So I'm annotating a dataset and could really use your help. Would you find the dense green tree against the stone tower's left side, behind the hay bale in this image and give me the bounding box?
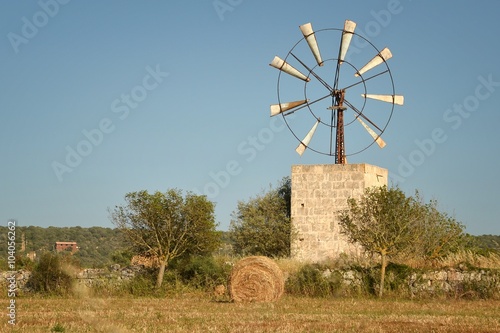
[229,178,291,257]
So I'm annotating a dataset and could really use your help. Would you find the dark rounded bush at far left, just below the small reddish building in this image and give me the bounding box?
[27,252,73,295]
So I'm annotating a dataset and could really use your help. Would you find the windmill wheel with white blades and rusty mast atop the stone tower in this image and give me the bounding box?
[270,20,404,164]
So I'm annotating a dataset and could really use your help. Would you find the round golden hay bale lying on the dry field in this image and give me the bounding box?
[229,256,285,302]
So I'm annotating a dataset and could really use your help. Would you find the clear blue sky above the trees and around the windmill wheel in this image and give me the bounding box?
[0,0,500,234]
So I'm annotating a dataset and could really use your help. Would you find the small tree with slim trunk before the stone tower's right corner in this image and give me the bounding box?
[339,186,422,297]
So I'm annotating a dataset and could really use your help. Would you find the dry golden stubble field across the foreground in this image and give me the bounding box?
[0,294,500,333]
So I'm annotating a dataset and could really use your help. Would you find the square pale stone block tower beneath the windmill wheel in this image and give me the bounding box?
[291,164,388,262]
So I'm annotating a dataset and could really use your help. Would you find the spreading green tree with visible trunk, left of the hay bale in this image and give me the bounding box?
[110,189,220,288]
